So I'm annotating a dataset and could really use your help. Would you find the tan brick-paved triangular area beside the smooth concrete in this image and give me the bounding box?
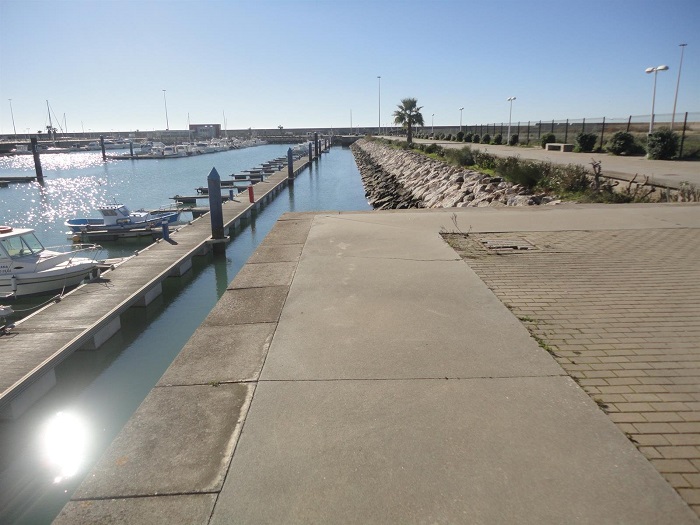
[445,229,700,515]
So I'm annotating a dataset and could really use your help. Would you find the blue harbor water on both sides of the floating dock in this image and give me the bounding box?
[0,145,370,524]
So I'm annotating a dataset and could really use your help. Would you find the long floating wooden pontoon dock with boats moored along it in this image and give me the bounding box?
[0,149,322,419]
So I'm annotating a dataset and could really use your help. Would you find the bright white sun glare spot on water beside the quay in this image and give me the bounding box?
[41,412,89,484]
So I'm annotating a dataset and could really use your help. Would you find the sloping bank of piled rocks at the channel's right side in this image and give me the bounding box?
[352,139,559,209]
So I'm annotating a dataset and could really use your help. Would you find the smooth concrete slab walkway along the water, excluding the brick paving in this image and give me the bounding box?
[56,205,700,524]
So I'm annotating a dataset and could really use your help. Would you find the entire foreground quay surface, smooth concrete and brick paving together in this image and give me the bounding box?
[55,205,700,525]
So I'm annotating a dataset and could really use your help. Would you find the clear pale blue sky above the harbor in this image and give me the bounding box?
[0,0,700,133]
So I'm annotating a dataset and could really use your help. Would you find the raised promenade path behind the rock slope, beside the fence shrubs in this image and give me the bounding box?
[404,137,700,189]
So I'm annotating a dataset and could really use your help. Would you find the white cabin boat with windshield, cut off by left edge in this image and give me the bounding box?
[0,226,100,298]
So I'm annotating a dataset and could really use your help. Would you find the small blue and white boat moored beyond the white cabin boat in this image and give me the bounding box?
[63,204,180,233]
